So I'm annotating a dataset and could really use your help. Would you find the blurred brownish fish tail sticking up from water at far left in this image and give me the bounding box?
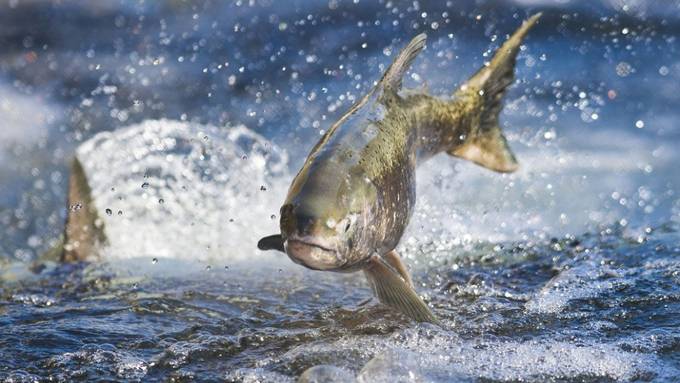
[61,157,107,262]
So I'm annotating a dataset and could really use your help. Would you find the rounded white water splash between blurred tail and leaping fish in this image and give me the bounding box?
[77,120,289,260]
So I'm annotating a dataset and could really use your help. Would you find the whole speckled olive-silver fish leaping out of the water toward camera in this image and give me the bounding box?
[258,13,541,323]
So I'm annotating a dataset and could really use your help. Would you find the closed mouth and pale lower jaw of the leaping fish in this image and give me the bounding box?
[285,237,342,270]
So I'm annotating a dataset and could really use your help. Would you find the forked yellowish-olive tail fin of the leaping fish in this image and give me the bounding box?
[449,13,541,173]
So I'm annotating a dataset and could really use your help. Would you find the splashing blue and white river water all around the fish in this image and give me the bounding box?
[0,0,680,382]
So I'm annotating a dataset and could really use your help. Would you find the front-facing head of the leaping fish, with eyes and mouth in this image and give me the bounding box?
[280,170,376,271]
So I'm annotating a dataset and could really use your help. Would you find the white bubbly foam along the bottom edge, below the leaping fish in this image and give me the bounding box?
[270,326,677,382]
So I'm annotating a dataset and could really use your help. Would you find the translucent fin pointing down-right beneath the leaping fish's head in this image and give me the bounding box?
[364,255,439,323]
